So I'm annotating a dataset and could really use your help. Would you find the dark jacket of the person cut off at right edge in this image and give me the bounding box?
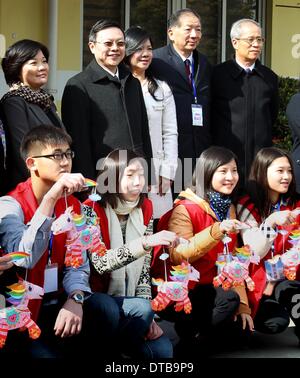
[286,92,300,193]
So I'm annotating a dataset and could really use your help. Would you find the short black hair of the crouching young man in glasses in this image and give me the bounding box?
[20,125,72,161]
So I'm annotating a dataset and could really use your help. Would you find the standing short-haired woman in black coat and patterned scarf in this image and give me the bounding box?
[1,39,63,189]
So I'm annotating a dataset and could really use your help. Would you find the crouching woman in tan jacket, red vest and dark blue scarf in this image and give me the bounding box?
[151,147,252,354]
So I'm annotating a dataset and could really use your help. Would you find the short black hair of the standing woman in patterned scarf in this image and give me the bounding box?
[2,39,49,86]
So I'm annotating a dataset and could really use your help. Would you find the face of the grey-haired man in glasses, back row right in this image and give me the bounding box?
[231,22,262,65]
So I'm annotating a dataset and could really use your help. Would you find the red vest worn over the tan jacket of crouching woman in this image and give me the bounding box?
[151,199,236,289]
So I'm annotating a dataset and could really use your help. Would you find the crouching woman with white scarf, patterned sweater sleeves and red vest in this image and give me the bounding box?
[85,150,176,359]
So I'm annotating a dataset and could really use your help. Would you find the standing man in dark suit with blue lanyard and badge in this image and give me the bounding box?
[151,8,211,192]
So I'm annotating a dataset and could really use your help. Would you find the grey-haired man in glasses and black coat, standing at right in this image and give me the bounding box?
[211,19,278,186]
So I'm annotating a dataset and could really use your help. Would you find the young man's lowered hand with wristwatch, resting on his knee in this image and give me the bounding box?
[54,298,83,337]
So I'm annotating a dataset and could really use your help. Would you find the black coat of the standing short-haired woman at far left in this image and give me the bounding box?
[1,96,63,191]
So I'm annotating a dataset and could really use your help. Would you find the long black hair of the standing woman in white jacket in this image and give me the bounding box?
[124,26,162,101]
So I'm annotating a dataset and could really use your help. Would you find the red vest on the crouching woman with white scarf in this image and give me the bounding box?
[84,198,153,293]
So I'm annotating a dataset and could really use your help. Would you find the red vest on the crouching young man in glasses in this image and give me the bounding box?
[8,178,81,321]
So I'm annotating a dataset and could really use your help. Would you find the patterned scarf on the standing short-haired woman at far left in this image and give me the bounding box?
[1,83,53,111]
